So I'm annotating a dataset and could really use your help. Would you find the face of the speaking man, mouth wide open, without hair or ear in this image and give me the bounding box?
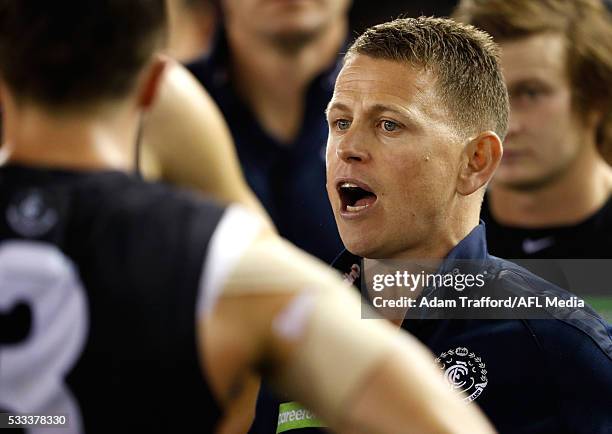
[327,55,461,258]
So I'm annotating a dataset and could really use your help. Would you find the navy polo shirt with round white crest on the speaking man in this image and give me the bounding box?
[257,224,612,434]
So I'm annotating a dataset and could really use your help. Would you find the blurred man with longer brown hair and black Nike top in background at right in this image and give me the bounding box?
[454,0,612,258]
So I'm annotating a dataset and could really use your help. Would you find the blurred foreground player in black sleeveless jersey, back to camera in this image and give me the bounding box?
[0,0,491,433]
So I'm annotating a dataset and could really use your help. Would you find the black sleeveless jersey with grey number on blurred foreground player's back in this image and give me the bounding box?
[0,165,225,434]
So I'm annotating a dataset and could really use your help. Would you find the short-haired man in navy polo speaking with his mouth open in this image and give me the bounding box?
[256,17,612,434]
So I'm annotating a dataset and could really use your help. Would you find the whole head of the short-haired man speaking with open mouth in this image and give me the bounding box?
[327,18,508,259]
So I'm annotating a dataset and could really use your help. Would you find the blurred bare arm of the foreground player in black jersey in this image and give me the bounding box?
[199,209,493,433]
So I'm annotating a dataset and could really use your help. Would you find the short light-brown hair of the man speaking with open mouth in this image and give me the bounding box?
[346,17,509,139]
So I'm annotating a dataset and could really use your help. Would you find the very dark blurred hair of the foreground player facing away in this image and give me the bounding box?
[0,0,166,108]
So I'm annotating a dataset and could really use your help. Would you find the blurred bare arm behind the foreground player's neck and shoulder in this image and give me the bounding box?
[141,60,272,231]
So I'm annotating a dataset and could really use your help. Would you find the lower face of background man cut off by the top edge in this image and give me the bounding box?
[223,0,350,39]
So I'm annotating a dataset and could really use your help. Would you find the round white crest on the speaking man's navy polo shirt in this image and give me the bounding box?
[436,347,489,402]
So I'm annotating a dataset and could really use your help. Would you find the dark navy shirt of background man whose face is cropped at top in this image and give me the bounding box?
[187,31,342,262]
